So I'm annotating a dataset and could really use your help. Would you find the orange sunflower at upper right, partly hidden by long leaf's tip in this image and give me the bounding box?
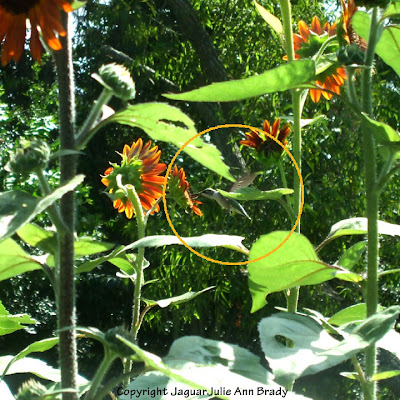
[293,17,346,103]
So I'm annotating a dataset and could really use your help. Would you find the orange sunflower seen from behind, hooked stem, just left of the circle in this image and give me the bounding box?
[101,138,167,219]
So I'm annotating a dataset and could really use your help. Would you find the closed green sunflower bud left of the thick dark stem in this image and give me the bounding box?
[6,139,50,175]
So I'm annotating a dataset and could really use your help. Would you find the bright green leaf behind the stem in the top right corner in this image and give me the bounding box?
[351,9,400,76]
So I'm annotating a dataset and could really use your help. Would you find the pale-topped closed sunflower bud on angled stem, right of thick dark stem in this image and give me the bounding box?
[94,63,136,100]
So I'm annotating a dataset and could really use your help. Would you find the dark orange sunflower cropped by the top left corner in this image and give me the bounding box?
[0,0,72,65]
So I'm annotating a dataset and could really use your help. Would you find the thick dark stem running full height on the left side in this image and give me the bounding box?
[55,12,78,400]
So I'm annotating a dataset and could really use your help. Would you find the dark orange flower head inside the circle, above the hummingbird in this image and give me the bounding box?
[239,118,290,165]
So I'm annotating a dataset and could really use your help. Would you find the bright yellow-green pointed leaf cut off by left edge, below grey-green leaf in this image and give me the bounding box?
[0,239,41,281]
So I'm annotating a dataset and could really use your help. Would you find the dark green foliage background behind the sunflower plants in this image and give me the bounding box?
[0,0,400,399]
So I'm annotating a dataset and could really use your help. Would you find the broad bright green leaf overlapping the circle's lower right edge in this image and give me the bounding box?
[248,231,347,312]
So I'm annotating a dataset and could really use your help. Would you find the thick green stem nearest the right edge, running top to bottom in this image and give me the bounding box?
[361,7,380,400]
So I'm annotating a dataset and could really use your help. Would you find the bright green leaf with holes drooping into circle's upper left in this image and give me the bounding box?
[96,103,235,182]
